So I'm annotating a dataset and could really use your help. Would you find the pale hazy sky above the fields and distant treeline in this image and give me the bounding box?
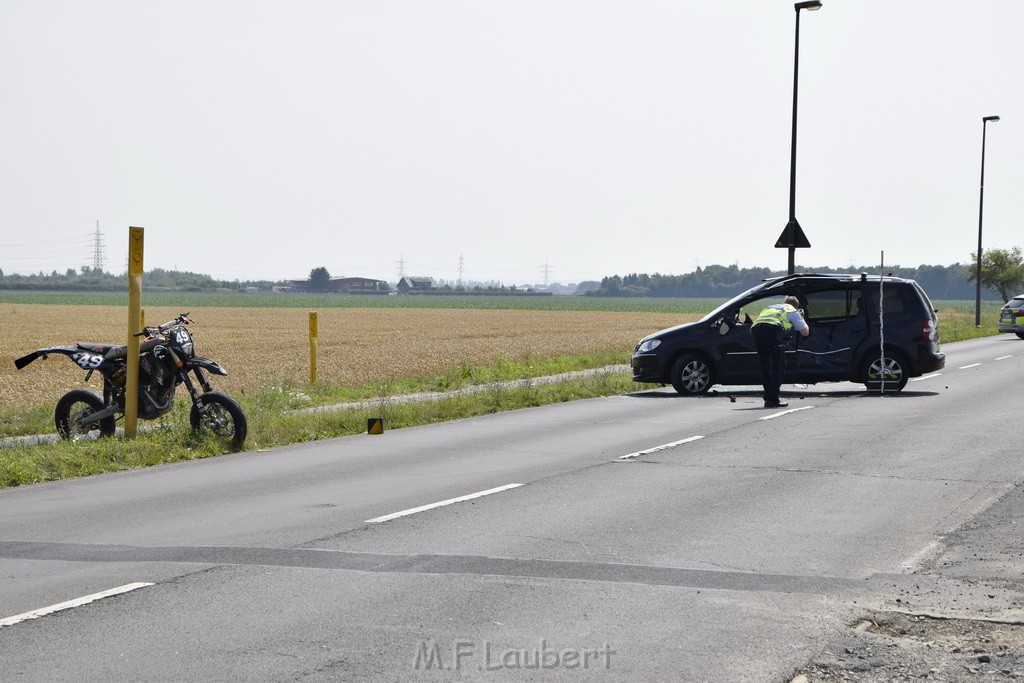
[0,0,1024,285]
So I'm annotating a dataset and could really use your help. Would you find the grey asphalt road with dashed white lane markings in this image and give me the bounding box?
[0,336,1024,681]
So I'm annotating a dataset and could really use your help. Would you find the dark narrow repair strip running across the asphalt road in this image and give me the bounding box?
[0,541,861,595]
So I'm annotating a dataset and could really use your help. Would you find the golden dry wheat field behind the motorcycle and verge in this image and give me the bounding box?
[0,303,698,410]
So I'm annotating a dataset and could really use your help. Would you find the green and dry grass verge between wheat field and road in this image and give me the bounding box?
[0,356,636,486]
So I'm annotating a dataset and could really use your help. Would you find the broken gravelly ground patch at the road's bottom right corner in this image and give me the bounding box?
[792,611,1024,683]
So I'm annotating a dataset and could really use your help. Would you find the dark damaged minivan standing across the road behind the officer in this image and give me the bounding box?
[631,273,946,395]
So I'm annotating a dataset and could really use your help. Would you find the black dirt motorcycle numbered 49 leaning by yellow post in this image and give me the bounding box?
[14,312,248,449]
